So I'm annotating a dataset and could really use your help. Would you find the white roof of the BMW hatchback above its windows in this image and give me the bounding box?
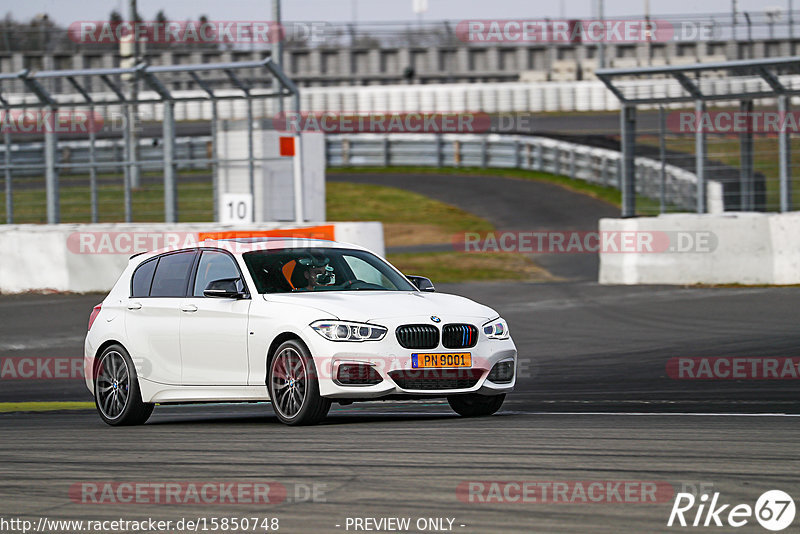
[131,237,368,262]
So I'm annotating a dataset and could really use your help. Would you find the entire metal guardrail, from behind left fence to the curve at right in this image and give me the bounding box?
[0,133,723,220]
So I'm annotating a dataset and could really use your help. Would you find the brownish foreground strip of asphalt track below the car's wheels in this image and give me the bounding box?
[0,406,800,533]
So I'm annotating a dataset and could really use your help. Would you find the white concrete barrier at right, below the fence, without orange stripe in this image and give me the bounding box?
[599,212,800,285]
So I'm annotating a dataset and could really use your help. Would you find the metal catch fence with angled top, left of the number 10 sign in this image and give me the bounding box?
[0,58,302,223]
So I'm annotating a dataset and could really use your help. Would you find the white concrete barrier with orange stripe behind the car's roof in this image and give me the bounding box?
[0,222,385,293]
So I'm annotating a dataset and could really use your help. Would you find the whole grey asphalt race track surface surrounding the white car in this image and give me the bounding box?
[0,179,800,533]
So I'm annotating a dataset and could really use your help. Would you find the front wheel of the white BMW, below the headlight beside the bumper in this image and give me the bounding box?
[267,339,331,426]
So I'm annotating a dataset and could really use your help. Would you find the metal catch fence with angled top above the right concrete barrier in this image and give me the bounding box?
[598,58,800,216]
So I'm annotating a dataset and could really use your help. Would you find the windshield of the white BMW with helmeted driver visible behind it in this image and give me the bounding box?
[244,248,417,294]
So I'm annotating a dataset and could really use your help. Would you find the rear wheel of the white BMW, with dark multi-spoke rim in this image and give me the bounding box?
[94,345,155,426]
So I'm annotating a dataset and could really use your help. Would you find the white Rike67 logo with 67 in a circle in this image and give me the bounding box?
[667,490,795,532]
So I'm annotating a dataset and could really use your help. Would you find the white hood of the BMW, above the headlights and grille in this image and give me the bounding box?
[264,291,498,323]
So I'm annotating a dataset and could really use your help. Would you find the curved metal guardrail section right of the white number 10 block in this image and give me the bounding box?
[326,134,723,212]
